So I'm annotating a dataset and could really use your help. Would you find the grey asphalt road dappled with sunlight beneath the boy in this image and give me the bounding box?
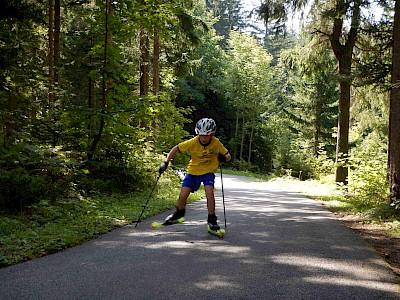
[0,175,400,300]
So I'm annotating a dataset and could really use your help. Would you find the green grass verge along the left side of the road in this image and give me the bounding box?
[0,172,203,267]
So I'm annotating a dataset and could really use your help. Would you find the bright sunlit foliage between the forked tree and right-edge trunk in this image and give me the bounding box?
[342,86,389,210]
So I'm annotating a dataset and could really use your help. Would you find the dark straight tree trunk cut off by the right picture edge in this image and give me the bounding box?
[388,0,400,204]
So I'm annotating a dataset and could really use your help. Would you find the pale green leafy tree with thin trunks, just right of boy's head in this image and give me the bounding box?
[226,31,272,164]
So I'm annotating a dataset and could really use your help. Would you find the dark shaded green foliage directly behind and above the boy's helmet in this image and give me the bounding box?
[175,25,236,144]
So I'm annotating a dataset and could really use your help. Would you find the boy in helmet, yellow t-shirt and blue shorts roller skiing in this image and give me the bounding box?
[158,118,231,231]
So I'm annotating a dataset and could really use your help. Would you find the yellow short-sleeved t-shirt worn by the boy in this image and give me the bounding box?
[178,136,228,175]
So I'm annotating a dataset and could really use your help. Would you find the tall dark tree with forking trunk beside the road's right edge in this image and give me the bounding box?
[258,0,380,183]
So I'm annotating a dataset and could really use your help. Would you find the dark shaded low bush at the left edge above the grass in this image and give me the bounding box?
[0,143,73,210]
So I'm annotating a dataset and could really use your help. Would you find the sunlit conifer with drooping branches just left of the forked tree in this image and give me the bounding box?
[280,39,337,157]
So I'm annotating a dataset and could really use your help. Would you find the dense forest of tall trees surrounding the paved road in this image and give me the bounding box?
[0,0,400,262]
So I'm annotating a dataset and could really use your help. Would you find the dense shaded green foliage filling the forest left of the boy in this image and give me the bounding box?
[0,0,200,213]
